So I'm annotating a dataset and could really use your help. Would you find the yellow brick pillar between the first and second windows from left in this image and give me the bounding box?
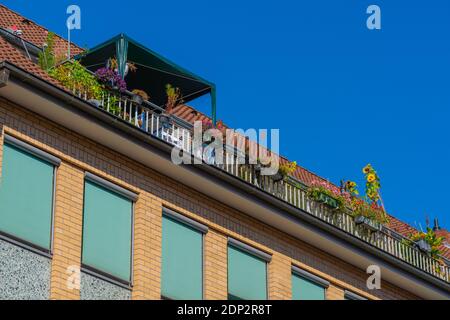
[50,163,84,300]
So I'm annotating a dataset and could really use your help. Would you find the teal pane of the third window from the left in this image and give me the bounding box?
[161,216,203,300]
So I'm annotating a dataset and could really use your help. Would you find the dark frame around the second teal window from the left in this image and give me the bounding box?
[80,172,139,290]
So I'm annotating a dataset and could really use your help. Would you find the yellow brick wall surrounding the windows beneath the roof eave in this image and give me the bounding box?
[0,98,417,299]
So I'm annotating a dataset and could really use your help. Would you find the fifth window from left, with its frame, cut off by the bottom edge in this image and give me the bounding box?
[292,267,330,300]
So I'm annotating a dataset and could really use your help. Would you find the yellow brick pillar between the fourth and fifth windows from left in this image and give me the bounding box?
[268,253,292,300]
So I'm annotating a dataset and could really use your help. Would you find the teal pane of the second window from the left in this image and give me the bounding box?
[82,181,133,282]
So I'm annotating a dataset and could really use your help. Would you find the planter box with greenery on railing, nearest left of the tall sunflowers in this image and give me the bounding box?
[307,180,350,211]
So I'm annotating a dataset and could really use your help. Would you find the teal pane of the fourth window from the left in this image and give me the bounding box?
[228,246,267,300]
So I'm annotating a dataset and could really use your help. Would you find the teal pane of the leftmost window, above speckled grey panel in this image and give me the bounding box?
[0,144,55,250]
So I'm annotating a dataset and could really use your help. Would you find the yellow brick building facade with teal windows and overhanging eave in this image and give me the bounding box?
[0,7,450,300]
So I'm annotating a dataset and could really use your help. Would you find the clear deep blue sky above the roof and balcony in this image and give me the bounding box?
[1,0,450,228]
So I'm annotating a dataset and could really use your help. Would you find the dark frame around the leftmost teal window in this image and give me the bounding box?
[0,133,62,258]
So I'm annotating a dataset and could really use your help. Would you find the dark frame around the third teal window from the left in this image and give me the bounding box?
[160,207,209,301]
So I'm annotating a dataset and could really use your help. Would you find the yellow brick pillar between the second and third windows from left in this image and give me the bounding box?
[132,194,162,300]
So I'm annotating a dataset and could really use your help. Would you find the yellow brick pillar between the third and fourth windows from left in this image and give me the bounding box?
[204,230,228,300]
